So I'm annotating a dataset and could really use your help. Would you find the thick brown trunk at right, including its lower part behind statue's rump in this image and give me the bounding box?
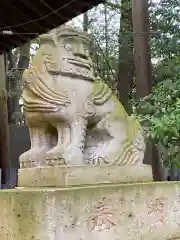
[132,0,163,181]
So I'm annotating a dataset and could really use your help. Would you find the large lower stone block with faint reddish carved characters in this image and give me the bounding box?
[0,182,180,240]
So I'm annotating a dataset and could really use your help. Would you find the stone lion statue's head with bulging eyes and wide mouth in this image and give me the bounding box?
[40,27,94,79]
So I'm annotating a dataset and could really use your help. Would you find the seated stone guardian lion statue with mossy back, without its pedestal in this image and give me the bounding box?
[20,27,145,168]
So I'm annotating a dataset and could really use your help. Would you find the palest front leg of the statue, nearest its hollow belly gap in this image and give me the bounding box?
[64,117,87,165]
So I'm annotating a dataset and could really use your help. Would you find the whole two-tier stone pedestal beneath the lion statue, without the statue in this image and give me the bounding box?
[0,166,180,240]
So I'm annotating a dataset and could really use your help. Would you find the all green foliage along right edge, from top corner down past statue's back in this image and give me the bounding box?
[133,0,180,167]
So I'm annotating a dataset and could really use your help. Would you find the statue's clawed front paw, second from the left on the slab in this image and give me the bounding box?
[45,147,66,166]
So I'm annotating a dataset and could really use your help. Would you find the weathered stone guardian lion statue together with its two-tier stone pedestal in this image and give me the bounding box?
[13,25,162,240]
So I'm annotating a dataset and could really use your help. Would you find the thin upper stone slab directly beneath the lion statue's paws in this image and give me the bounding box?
[18,165,152,187]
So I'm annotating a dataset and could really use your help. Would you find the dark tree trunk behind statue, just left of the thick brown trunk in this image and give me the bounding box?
[117,0,134,114]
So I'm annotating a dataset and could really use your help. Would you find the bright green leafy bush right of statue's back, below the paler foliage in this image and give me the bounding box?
[135,57,180,165]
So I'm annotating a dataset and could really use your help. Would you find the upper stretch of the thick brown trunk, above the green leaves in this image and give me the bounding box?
[133,0,152,98]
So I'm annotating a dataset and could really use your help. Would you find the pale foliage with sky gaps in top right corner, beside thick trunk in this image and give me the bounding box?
[150,0,180,58]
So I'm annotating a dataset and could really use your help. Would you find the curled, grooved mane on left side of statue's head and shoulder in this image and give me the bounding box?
[23,28,93,112]
